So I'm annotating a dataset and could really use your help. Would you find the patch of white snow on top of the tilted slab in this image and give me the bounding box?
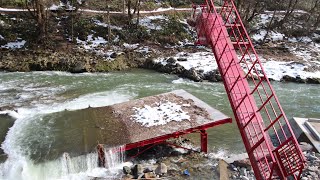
[131,101,190,127]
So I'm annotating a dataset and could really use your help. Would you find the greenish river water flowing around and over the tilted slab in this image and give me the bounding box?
[0,70,320,180]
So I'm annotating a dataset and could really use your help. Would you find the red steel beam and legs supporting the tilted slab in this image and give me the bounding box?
[97,118,232,167]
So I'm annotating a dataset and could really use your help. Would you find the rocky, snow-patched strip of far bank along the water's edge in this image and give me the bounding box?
[0,45,320,84]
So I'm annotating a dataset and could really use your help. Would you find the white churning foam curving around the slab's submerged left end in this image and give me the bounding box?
[0,90,136,179]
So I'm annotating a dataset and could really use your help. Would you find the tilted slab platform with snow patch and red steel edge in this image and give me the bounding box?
[91,90,232,152]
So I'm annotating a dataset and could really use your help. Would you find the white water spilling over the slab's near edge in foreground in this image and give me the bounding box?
[0,146,131,180]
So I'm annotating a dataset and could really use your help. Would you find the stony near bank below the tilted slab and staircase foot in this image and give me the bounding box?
[116,141,320,180]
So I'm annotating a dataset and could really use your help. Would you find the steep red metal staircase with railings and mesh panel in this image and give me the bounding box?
[193,0,305,179]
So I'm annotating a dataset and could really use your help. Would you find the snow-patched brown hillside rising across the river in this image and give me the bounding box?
[0,1,320,83]
